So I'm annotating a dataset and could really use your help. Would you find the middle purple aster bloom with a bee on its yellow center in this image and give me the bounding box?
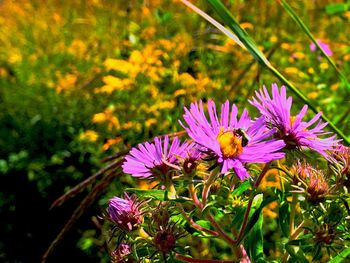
[181,100,285,180]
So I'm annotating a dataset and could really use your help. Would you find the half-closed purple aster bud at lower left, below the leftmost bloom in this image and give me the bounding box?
[108,193,143,231]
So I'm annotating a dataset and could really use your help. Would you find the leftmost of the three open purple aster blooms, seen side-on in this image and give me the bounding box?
[122,136,194,178]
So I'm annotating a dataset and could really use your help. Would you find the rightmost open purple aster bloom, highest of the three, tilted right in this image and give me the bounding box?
[249,84,338,158]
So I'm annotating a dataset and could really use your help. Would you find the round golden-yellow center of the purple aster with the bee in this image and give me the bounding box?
[217,128,243,158]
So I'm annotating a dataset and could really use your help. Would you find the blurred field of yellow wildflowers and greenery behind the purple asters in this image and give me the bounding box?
[0,0,350,262]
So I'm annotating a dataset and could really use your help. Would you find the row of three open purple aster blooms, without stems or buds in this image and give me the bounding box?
[123,84,338,180]
